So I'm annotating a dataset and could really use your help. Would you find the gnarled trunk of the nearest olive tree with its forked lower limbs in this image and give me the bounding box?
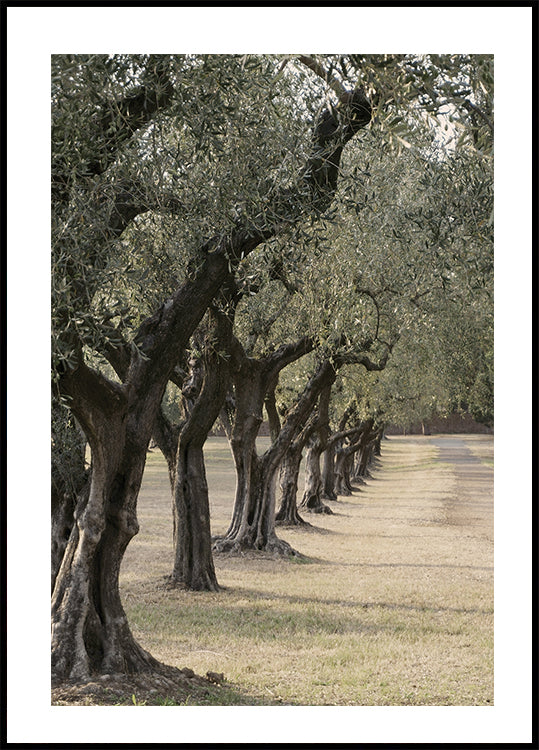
[51,248,227,680]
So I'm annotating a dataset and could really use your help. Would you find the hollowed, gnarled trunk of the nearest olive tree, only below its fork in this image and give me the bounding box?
[52,384,163,680]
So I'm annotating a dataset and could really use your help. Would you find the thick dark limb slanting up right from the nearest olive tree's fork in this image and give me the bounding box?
[88,70,371,408]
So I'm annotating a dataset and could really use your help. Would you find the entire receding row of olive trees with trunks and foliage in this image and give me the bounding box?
[52,55,492,679]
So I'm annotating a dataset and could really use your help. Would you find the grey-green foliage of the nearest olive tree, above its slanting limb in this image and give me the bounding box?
[52,55,309,382]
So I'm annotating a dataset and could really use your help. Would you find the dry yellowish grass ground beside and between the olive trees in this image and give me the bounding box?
[121,436,493,705]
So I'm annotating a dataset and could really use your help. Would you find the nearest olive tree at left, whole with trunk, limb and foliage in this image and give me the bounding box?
[52,55,371,679]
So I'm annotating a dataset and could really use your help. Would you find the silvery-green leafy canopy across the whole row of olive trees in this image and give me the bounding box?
[52,55,493,440]
